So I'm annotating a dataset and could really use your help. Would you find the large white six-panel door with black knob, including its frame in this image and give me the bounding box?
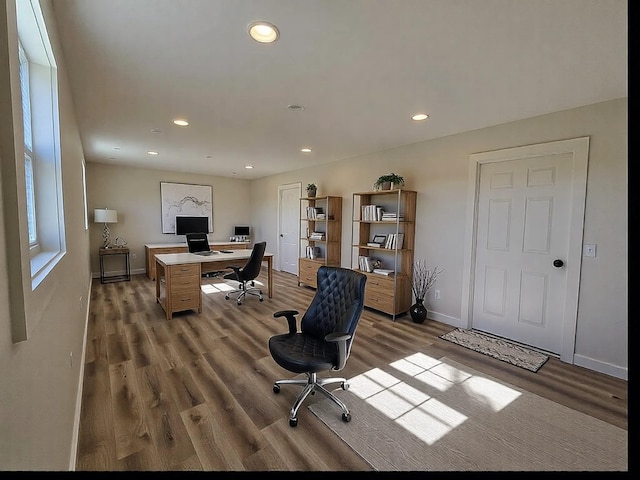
[462,138,588,363]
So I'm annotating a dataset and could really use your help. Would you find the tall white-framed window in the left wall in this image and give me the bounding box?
[16,0,66,289]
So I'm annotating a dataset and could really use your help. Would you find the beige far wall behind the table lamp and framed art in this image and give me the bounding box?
[87,162,251,277]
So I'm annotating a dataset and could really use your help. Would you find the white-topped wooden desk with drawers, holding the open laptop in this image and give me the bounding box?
[155,249,273,320]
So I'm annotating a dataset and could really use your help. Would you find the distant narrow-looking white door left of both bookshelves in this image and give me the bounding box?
[278,183,302,275]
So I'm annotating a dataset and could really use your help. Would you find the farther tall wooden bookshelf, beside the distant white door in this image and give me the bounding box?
[298,196,342,288]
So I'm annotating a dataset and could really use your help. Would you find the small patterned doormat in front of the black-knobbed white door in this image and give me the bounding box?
[440,328,549,372]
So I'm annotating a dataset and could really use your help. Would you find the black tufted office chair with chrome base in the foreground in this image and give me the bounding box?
[269,265,367,427]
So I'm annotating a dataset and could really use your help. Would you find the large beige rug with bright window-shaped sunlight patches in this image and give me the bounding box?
[309,353,628,471]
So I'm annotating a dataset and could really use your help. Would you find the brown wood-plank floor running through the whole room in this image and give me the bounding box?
[76,272,628,471]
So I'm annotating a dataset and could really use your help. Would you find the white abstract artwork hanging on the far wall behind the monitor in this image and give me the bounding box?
[160,182,213,233]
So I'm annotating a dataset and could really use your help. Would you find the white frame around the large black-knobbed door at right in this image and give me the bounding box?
[460,137,589,364]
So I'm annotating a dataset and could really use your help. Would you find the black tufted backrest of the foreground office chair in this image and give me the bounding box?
[300,265,367,351]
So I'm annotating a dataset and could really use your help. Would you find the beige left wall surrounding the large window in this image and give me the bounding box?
[0,0,91,470]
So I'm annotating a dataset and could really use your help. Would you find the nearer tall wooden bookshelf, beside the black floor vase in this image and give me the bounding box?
[351,189,418,320]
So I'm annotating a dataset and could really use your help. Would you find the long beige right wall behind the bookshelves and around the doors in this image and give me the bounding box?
[251,99,628,378]
